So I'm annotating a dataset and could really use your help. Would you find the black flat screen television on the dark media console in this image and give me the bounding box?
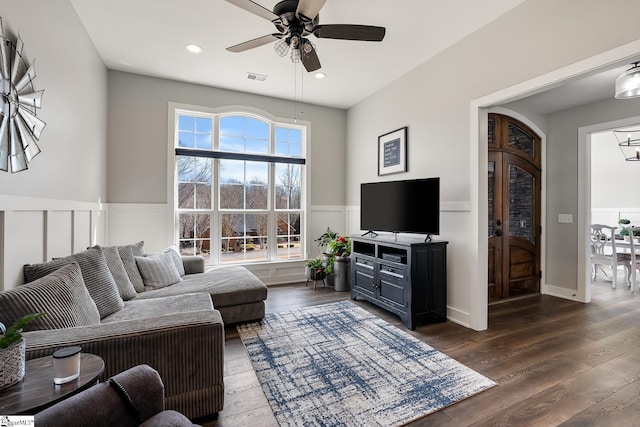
[360,177,440,239]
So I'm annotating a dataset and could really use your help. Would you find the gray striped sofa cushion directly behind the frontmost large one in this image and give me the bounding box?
[24,248,124,318]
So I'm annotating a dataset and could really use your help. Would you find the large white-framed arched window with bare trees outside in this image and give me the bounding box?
[174,108,307,265]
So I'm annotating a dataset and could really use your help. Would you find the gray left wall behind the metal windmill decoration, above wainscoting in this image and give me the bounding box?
[0,0,107,202]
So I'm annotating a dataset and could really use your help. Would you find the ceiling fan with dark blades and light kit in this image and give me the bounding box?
[227,0,386,72]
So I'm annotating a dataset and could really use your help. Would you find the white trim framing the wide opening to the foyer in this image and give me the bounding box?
[469,40,640,331]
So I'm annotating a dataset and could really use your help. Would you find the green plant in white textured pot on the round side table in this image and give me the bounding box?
[0,313,44,390]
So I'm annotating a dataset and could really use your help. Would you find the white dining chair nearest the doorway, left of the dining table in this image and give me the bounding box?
[591,224,640,289]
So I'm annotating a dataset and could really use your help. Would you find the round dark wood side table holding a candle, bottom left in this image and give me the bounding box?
[0,353,104,415]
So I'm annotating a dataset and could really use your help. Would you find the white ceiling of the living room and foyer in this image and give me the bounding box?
[71,0,631,113]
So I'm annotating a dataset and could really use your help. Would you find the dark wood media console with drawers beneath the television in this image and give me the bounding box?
[351,237,448,330]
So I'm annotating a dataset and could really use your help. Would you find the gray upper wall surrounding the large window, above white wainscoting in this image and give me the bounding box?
[108,71,346,205]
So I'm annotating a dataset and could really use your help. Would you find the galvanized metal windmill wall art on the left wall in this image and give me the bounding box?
[0,18,46,173]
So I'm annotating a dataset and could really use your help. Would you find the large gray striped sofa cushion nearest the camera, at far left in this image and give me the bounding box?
[0,262,100,331]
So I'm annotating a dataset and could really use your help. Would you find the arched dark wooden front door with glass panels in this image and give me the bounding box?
[488,114,541,303]
